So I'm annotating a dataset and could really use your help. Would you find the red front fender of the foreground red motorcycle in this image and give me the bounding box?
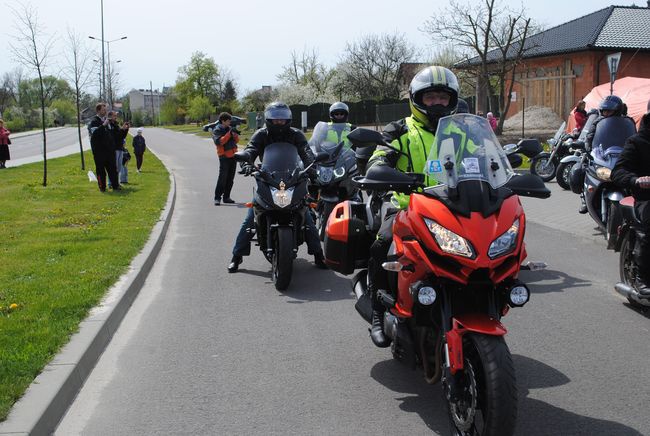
[446,313,508,374]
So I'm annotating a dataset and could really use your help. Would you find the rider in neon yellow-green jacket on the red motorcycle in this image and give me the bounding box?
[368,66,472,347]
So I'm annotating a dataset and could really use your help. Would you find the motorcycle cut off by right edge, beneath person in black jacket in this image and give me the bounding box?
[614,197,650,308]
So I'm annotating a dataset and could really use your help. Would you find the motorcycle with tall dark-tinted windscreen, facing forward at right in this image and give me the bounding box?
[571,117,636,248]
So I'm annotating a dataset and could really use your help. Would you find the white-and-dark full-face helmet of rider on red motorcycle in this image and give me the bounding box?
[409,66,458,130]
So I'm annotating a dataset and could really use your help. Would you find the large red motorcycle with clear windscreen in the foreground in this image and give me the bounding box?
[325,114,550,436]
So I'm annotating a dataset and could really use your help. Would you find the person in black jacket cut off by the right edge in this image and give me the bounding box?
[611,101,650,298]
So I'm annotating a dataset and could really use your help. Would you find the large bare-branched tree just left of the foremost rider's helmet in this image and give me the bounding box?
[337,34,415,100]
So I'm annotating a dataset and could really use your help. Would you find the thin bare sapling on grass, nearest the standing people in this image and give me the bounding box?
[63,27,94,170]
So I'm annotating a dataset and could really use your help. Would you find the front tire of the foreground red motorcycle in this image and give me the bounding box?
[443,333,517,436]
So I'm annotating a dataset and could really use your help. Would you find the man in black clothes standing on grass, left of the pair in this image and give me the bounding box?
[88,103,121,192]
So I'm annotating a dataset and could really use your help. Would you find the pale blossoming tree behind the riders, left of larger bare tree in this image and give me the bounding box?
[277,49,335,100]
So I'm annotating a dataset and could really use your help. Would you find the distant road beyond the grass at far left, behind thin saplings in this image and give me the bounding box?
[7,126,88,167]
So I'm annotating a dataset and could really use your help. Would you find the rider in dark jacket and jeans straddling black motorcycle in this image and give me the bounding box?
[228,101,327,273]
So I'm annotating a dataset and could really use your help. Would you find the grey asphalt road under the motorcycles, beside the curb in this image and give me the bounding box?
[56,129,650,435]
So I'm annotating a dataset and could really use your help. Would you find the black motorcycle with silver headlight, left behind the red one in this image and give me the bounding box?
[235,143,326,291]
